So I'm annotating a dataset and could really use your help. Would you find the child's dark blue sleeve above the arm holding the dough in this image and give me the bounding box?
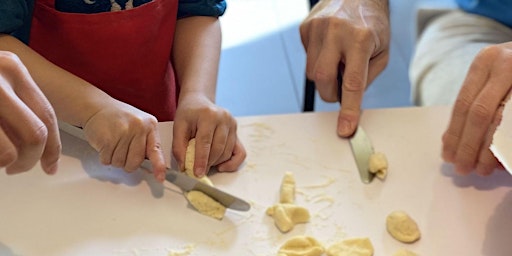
[178,0,226,19]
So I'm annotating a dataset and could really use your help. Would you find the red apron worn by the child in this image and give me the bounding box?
[29,0,178,121]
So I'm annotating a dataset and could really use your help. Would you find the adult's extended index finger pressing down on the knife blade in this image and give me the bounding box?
[338,48,370,137]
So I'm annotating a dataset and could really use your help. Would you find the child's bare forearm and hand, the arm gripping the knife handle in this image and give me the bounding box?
[0,34,165,180]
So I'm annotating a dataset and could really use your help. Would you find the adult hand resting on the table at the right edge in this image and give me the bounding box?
[442,42,512,175]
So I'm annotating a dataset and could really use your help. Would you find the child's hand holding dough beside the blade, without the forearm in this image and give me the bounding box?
[172,94,247,177]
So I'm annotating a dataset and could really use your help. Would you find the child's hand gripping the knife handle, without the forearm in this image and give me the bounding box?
[83,100,165,181]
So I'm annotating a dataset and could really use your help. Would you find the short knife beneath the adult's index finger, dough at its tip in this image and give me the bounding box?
[338,72,375,184]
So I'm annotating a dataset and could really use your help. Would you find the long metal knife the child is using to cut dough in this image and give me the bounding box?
[59,121,251,211]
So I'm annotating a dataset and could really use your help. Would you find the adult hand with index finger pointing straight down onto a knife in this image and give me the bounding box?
[300,0,390,137]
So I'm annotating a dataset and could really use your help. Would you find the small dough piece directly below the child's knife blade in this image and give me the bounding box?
[186,190,226,220]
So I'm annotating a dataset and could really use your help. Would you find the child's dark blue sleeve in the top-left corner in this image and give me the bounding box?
[0,0,34,43]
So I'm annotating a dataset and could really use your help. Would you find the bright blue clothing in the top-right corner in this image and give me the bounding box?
[457,0,512,27]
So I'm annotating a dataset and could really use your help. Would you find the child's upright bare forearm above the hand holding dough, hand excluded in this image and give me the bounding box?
[172,16,221,101]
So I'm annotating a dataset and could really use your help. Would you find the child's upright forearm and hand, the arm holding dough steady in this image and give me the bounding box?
[172,16,246,176]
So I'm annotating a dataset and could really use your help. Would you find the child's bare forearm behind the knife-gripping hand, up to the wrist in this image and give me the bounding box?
[0,35,113,127]
